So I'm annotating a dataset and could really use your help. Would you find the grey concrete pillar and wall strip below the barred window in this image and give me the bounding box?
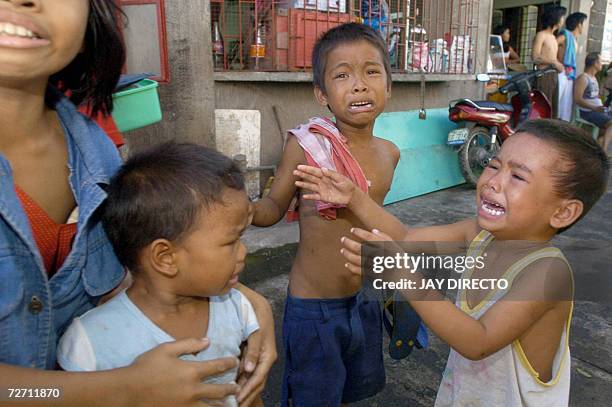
[125,0,493,165]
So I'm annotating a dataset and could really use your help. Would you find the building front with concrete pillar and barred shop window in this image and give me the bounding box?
[122,0,597,196]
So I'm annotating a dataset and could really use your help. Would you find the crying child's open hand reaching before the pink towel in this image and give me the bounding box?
[293,165,356,205]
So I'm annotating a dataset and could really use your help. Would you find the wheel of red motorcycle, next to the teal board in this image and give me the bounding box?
[459,126,500,187]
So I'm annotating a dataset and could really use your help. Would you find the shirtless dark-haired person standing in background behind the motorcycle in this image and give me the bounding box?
[532,6,567,118]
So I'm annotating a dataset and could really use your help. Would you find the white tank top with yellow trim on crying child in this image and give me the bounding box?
[435,231,573,407]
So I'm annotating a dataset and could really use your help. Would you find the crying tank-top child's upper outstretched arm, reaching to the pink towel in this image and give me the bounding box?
[294,165,475,242]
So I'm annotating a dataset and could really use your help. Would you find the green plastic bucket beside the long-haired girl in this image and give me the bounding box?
[112,79,162,132]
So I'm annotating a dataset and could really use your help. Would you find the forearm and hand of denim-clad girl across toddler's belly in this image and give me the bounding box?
[0,339,238,407]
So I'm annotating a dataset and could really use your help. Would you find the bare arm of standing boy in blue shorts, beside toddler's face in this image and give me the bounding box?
[252,136,306,226]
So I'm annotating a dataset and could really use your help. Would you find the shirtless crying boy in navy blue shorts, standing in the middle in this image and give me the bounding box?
[252,23,399,407]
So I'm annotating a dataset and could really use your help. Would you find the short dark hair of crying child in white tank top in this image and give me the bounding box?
[516,119,610,233]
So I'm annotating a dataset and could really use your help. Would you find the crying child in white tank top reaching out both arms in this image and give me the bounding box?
[296,120,609,406]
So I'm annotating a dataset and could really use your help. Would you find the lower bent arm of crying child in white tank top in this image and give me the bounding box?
[342,229,571,360]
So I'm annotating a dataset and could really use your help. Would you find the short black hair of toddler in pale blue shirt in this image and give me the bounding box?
[102,142,244,271]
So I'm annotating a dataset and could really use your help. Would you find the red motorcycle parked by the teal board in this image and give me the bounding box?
[447,66,556,186]
